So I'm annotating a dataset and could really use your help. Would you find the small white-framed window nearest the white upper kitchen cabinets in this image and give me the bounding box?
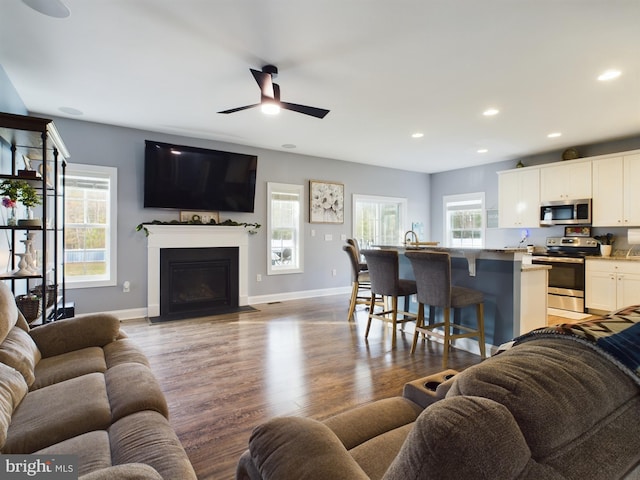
[442,192,485,248]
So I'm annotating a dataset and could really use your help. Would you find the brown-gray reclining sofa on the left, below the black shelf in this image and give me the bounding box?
[0,282,196,480]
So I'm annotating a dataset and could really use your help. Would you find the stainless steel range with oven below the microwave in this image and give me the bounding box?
[532,237,600,313]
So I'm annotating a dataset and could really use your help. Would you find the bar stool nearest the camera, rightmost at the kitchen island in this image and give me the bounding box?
[405,252,486,368]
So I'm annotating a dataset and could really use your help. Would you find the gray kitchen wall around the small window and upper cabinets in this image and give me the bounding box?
[429,135,640,249]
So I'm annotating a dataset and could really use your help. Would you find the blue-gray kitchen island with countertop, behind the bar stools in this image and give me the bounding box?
[378,246,549,352]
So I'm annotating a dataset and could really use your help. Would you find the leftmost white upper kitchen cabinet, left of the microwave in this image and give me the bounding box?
[498,168,540,228]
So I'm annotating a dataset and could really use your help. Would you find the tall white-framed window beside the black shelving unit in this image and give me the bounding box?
[64,163,118,288]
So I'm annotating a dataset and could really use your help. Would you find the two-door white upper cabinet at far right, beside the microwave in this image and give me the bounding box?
[592,154,640,227]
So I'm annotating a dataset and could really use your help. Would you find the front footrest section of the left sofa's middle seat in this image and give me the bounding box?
[105,363,169,422]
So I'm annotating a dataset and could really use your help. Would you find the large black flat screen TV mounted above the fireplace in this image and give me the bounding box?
[144,140,258,212]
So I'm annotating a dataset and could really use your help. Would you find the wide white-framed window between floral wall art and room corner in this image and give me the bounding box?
[352,194,407,248]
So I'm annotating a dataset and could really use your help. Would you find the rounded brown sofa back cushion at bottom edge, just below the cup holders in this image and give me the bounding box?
[384,396,562,480]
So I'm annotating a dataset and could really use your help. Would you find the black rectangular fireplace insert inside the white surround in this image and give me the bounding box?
[155,247,238,320]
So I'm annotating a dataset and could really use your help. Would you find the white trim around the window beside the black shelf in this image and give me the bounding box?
[63,163,118,289]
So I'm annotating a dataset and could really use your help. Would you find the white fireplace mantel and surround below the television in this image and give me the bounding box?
[145,225,249,317]
